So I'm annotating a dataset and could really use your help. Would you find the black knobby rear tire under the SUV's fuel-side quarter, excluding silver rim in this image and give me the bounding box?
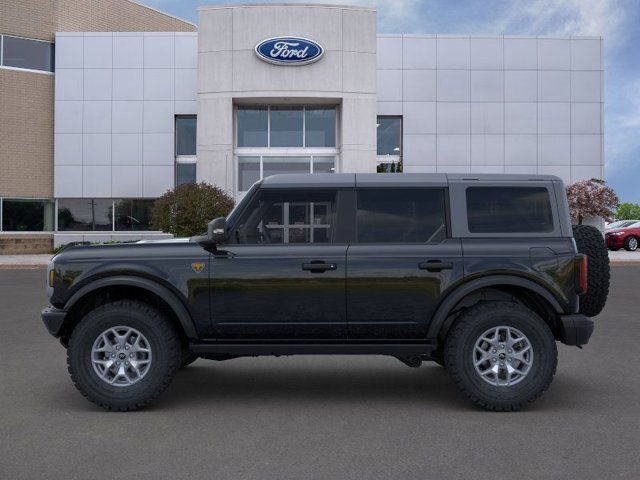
[444,302,558,411]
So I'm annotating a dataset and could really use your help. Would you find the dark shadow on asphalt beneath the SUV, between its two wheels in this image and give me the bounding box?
[158,358,465,408]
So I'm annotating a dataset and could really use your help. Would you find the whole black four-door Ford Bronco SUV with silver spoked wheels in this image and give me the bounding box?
[42,174,609,411]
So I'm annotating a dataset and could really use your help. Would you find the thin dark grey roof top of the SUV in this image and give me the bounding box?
[261,173,560,188]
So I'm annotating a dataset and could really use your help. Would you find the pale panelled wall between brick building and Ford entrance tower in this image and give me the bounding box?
[54,32,197,198]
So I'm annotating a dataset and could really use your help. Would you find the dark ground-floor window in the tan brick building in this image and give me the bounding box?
[0,198,55,232]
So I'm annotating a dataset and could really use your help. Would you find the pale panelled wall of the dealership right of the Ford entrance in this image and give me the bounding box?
[377,35,604,183]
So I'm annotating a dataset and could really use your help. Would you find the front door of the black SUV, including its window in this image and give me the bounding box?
[210,189,347,340]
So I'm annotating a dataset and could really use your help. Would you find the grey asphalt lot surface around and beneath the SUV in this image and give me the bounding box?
[0,266,640,480]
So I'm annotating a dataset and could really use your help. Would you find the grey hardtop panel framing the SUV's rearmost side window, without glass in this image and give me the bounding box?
[449,182,566,239]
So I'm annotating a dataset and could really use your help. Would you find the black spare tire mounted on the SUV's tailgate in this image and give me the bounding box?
[573,225,610,317]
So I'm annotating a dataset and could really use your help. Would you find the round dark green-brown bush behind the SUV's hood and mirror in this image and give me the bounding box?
[151,182,233,237]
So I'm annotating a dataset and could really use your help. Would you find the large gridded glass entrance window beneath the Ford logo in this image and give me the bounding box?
[236,105,338,192]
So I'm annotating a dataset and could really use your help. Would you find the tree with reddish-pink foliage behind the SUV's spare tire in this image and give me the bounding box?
[567,178,620,225]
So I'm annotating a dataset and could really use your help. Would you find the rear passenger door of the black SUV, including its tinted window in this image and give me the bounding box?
[347,187,463,339]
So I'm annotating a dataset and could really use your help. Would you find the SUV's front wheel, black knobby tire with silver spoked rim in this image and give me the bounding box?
[67,300,182,411]
